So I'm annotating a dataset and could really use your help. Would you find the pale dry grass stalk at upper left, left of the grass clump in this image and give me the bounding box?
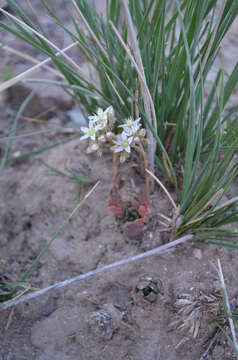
[0,41,78,92]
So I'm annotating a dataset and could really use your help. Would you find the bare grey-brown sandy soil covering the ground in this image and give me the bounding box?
[0,1,238,360]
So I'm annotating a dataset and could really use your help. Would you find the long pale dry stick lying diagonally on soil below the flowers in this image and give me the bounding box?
[0,234,193,312]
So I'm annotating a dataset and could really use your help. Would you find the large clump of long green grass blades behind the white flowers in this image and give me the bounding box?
[0,0,238,248]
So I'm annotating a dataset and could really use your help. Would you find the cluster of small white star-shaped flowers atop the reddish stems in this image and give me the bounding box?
[81,106,146,163]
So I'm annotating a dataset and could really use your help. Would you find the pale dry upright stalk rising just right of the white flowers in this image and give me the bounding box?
[121,0,157,172]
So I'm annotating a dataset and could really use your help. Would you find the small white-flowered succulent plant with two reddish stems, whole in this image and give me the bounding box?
[80,106,150,234]
